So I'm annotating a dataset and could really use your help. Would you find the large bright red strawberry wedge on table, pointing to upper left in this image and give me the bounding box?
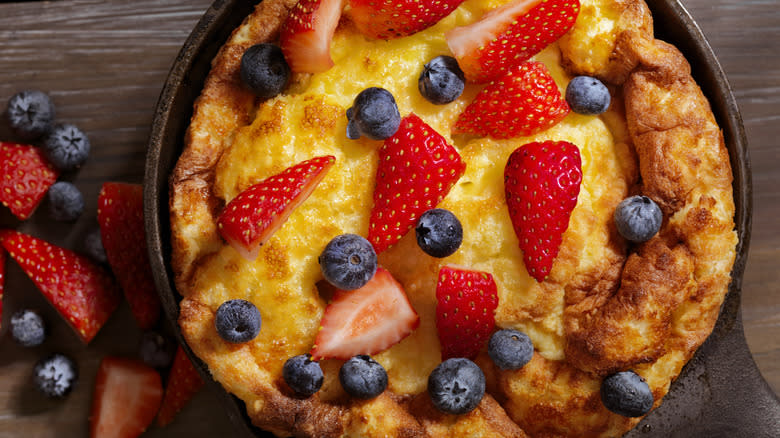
[2,231,122,344]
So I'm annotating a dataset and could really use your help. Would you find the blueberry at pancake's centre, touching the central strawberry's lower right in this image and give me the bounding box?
[414,208,463,258]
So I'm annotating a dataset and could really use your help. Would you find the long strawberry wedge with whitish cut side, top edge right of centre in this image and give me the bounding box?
[446,0,580,83]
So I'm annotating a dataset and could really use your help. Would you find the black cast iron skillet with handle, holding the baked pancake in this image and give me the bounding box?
[144,0,780,438]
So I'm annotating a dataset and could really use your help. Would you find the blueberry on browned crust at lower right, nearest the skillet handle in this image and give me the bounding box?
[601,371,653,417]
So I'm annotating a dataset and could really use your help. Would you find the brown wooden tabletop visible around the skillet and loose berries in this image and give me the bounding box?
[0,0,780,438]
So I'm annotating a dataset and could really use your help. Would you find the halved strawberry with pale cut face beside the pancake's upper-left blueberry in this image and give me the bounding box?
[279,0,346,73]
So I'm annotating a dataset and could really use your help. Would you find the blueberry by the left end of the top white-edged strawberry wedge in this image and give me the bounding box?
[417,56,466,105]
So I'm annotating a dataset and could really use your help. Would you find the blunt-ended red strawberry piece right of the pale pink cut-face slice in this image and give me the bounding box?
[436,266,498,360]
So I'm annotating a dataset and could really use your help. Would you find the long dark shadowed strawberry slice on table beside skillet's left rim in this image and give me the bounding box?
[98,182,161,330]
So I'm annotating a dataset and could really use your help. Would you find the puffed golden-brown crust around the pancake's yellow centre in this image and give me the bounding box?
[170,0,737,437]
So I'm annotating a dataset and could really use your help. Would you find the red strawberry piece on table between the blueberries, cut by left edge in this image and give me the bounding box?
[0,142,59,220]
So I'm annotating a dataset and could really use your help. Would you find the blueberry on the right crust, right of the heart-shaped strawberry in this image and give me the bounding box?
[614,196,664,243]
